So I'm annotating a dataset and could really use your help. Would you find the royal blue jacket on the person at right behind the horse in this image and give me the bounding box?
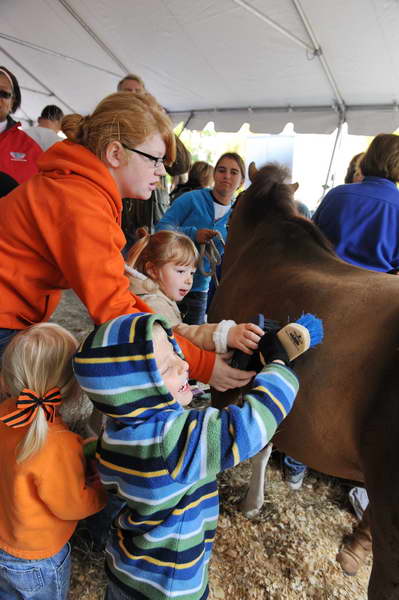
[313,177,399,272]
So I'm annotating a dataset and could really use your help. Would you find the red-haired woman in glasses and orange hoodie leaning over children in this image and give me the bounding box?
[0,92,253,390]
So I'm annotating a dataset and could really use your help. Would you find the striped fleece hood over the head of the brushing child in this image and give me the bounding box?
[73,313,183,423]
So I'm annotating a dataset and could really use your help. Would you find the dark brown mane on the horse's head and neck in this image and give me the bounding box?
[239,163,335,255]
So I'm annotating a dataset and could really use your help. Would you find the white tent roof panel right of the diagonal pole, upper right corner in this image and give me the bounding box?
[302,0,399,105]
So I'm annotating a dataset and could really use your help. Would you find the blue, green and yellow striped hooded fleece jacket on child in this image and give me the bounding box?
[74,313,298,600]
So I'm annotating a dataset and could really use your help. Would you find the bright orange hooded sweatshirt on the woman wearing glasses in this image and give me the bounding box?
[0,141,215,381]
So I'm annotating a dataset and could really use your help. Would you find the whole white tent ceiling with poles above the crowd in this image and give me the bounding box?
[0,0,399,135]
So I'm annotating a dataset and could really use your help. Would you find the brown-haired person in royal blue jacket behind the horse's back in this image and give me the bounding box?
[313,133,399,273]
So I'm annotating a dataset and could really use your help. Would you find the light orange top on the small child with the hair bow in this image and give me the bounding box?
[0,399,106,560]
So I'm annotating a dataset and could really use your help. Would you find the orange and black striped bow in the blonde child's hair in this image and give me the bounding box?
[0,388,62,427]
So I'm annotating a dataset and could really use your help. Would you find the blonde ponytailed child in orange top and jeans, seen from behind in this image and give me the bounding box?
[0,323,105,600]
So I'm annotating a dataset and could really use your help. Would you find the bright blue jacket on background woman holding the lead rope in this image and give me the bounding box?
[155,188,231,292]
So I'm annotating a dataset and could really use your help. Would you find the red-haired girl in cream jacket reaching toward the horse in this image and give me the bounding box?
[125,228,263,354]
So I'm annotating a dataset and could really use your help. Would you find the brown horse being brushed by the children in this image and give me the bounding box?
[210,165,399,600]
